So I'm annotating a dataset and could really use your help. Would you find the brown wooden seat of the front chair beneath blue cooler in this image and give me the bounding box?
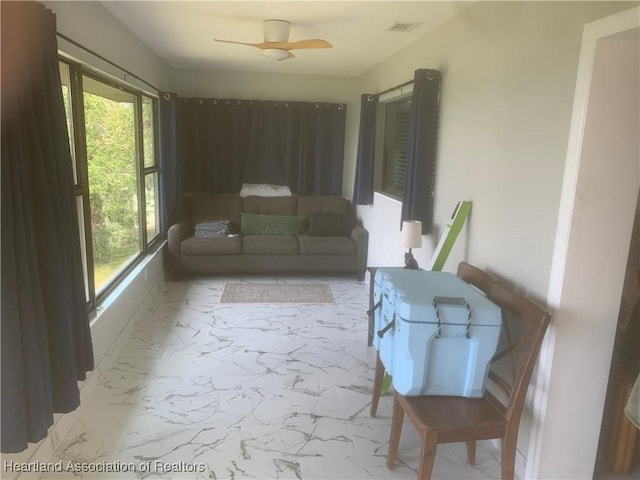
[396,395,507,443]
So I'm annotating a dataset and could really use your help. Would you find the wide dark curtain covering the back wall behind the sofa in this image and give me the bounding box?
[160,98,346,197]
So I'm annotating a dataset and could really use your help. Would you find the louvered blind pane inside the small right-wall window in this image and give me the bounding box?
[381,98,411,198]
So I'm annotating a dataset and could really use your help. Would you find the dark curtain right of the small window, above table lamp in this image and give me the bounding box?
[401,69,440,235]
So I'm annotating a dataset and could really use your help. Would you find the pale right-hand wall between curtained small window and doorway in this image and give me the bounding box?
[347,2,633,464]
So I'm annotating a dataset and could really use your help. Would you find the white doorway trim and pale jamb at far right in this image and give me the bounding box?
[526,7,640,479]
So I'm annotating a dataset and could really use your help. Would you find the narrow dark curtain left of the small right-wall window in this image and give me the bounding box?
[353,93,378,205]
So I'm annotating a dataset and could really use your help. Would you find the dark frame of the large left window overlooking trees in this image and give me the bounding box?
[58,55,162,311]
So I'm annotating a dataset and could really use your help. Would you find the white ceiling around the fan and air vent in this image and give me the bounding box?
[102,0,472,75]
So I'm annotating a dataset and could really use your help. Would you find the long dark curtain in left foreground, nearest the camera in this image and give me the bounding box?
[0,2,93,453]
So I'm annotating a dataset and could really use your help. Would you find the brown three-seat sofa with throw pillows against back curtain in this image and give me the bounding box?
[168,193,369,280]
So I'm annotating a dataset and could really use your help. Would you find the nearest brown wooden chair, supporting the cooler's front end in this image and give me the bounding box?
[387,284,550,479]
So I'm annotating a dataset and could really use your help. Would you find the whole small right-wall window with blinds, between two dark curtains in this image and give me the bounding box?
[374,96,411,199]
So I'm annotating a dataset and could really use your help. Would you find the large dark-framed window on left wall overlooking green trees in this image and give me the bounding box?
[60,61,160,306]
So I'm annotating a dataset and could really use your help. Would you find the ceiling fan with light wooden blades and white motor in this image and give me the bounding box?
[214,20,333,60]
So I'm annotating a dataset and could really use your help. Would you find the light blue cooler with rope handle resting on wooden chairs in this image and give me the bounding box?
[380,269,502,397]
